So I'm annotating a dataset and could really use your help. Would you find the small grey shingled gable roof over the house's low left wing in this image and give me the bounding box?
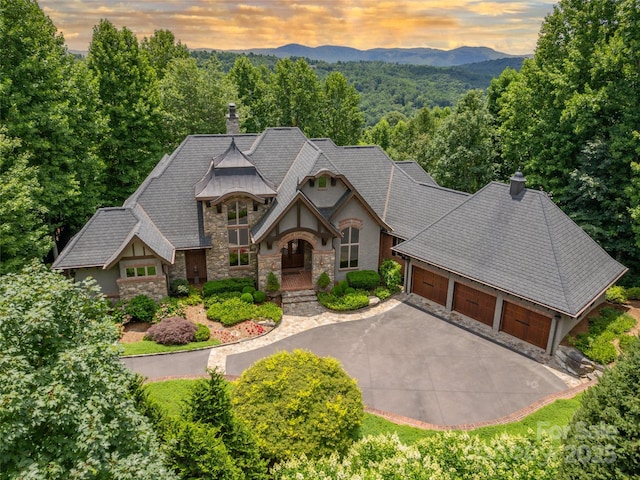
[53,203,175,269]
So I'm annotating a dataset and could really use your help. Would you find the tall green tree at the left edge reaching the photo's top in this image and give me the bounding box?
[0,0,105,253]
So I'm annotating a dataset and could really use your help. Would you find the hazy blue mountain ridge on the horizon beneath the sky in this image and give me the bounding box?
[229,43,523,67]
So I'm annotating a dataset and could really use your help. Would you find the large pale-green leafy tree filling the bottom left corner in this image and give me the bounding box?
[0,263,174,480]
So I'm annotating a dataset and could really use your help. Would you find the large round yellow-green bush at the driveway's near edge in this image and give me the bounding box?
[232,350,364,463]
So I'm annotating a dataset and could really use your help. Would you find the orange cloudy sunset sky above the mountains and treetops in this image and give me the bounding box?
[39,0,555,54]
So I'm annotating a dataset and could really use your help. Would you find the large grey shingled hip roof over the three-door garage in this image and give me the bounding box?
[394,182,627,317]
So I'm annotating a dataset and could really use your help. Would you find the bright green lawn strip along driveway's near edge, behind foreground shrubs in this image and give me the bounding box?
[145,380,581,444]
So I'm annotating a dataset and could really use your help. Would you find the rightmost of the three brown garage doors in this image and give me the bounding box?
[501,302,551,349]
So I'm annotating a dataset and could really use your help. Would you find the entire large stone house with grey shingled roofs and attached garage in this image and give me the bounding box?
[53,107,626,353]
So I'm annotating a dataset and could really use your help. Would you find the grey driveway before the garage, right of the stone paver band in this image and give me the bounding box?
[226,303,567,425]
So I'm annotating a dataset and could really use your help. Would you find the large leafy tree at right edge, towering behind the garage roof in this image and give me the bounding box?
[500,0,640,281]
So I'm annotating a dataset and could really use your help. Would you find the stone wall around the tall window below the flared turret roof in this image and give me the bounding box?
[203,198,269,280]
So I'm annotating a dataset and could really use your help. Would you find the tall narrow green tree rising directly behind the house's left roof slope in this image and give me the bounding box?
[87,20,165,205]
